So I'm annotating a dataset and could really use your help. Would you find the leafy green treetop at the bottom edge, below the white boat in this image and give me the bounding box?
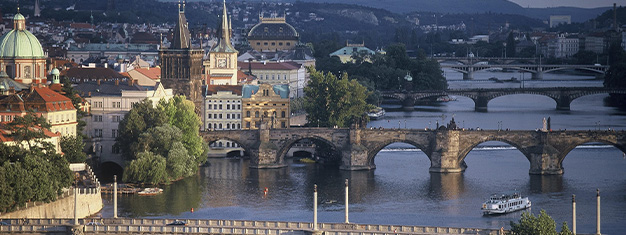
[511,210,572,235]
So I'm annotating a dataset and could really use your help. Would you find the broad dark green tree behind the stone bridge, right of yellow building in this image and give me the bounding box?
[304,68,374,127]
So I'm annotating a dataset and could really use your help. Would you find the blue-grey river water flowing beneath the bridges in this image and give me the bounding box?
[97,71,626,234]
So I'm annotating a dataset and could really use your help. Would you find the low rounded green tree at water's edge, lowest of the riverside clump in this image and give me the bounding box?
[124,152,169,185]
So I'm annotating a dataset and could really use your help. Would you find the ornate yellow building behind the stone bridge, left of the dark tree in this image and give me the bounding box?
[241,84,290,130]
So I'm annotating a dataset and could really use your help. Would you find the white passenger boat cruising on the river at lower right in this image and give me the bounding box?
[482,192,531,215]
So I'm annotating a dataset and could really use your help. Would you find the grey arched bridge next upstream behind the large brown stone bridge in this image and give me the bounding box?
[381,87,626,111]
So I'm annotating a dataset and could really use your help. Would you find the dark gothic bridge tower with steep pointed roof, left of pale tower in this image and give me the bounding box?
[159,2,204,113]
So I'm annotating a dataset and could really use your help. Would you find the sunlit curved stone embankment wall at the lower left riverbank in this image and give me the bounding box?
[0,163,103,219]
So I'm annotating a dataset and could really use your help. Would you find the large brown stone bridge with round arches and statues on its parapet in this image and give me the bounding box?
[201,125,626,175]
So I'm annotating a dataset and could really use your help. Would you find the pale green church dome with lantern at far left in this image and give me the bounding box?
[0,13,45,58]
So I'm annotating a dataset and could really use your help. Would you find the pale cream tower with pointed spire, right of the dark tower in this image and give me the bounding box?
[208,0,238,85]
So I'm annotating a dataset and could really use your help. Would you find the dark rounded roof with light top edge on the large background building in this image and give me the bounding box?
[248,17,299,40]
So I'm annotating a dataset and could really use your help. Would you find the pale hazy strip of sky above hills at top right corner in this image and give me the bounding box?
[509,0,626,8]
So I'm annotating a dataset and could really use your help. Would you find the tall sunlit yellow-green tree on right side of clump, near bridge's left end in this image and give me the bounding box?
[158,96,209,165]
